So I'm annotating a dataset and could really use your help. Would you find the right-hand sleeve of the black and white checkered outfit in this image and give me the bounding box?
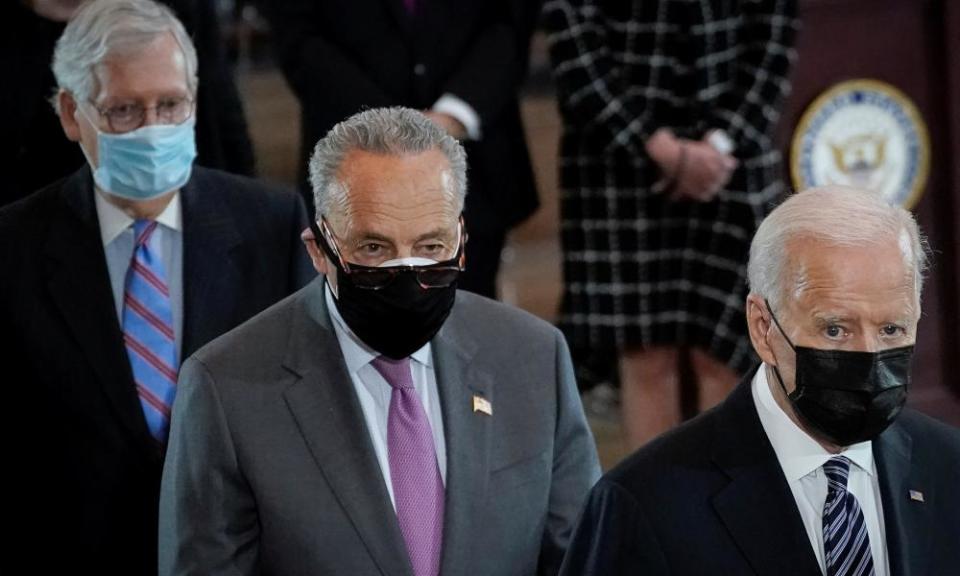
[690,0,799,157]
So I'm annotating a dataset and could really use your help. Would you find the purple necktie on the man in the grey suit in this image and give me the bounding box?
[371,356,443,576]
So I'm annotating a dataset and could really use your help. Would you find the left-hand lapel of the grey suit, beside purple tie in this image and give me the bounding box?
[284,286,412,576]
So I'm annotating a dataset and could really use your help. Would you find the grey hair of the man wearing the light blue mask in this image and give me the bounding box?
[51,0,197,112]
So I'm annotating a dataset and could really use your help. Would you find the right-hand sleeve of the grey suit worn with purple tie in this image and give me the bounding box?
[538,332,600,576]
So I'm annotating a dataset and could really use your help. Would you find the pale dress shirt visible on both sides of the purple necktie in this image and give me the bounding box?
[324,284,447,510]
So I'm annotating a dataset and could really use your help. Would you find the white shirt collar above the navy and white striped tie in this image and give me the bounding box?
[751,364,876,482]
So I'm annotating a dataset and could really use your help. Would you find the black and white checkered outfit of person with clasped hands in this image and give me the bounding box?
[544,0,798,372]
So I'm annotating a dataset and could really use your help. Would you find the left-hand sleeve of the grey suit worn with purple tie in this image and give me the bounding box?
[159,358,259,576]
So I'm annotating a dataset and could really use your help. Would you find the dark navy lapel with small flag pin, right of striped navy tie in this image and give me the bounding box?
[873,423,936,576]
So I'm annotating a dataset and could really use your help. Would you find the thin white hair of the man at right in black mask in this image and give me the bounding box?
[747,186,927,310]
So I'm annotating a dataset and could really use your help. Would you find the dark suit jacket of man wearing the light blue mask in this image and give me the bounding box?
[0,168,315,574]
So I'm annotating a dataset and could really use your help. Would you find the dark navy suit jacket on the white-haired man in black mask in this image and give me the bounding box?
[561,368,960,576]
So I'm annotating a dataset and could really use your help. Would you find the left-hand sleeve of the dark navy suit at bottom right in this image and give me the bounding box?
[560,480,670,576]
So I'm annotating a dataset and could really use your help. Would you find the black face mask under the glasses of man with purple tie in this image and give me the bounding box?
[310,220,462,360]
